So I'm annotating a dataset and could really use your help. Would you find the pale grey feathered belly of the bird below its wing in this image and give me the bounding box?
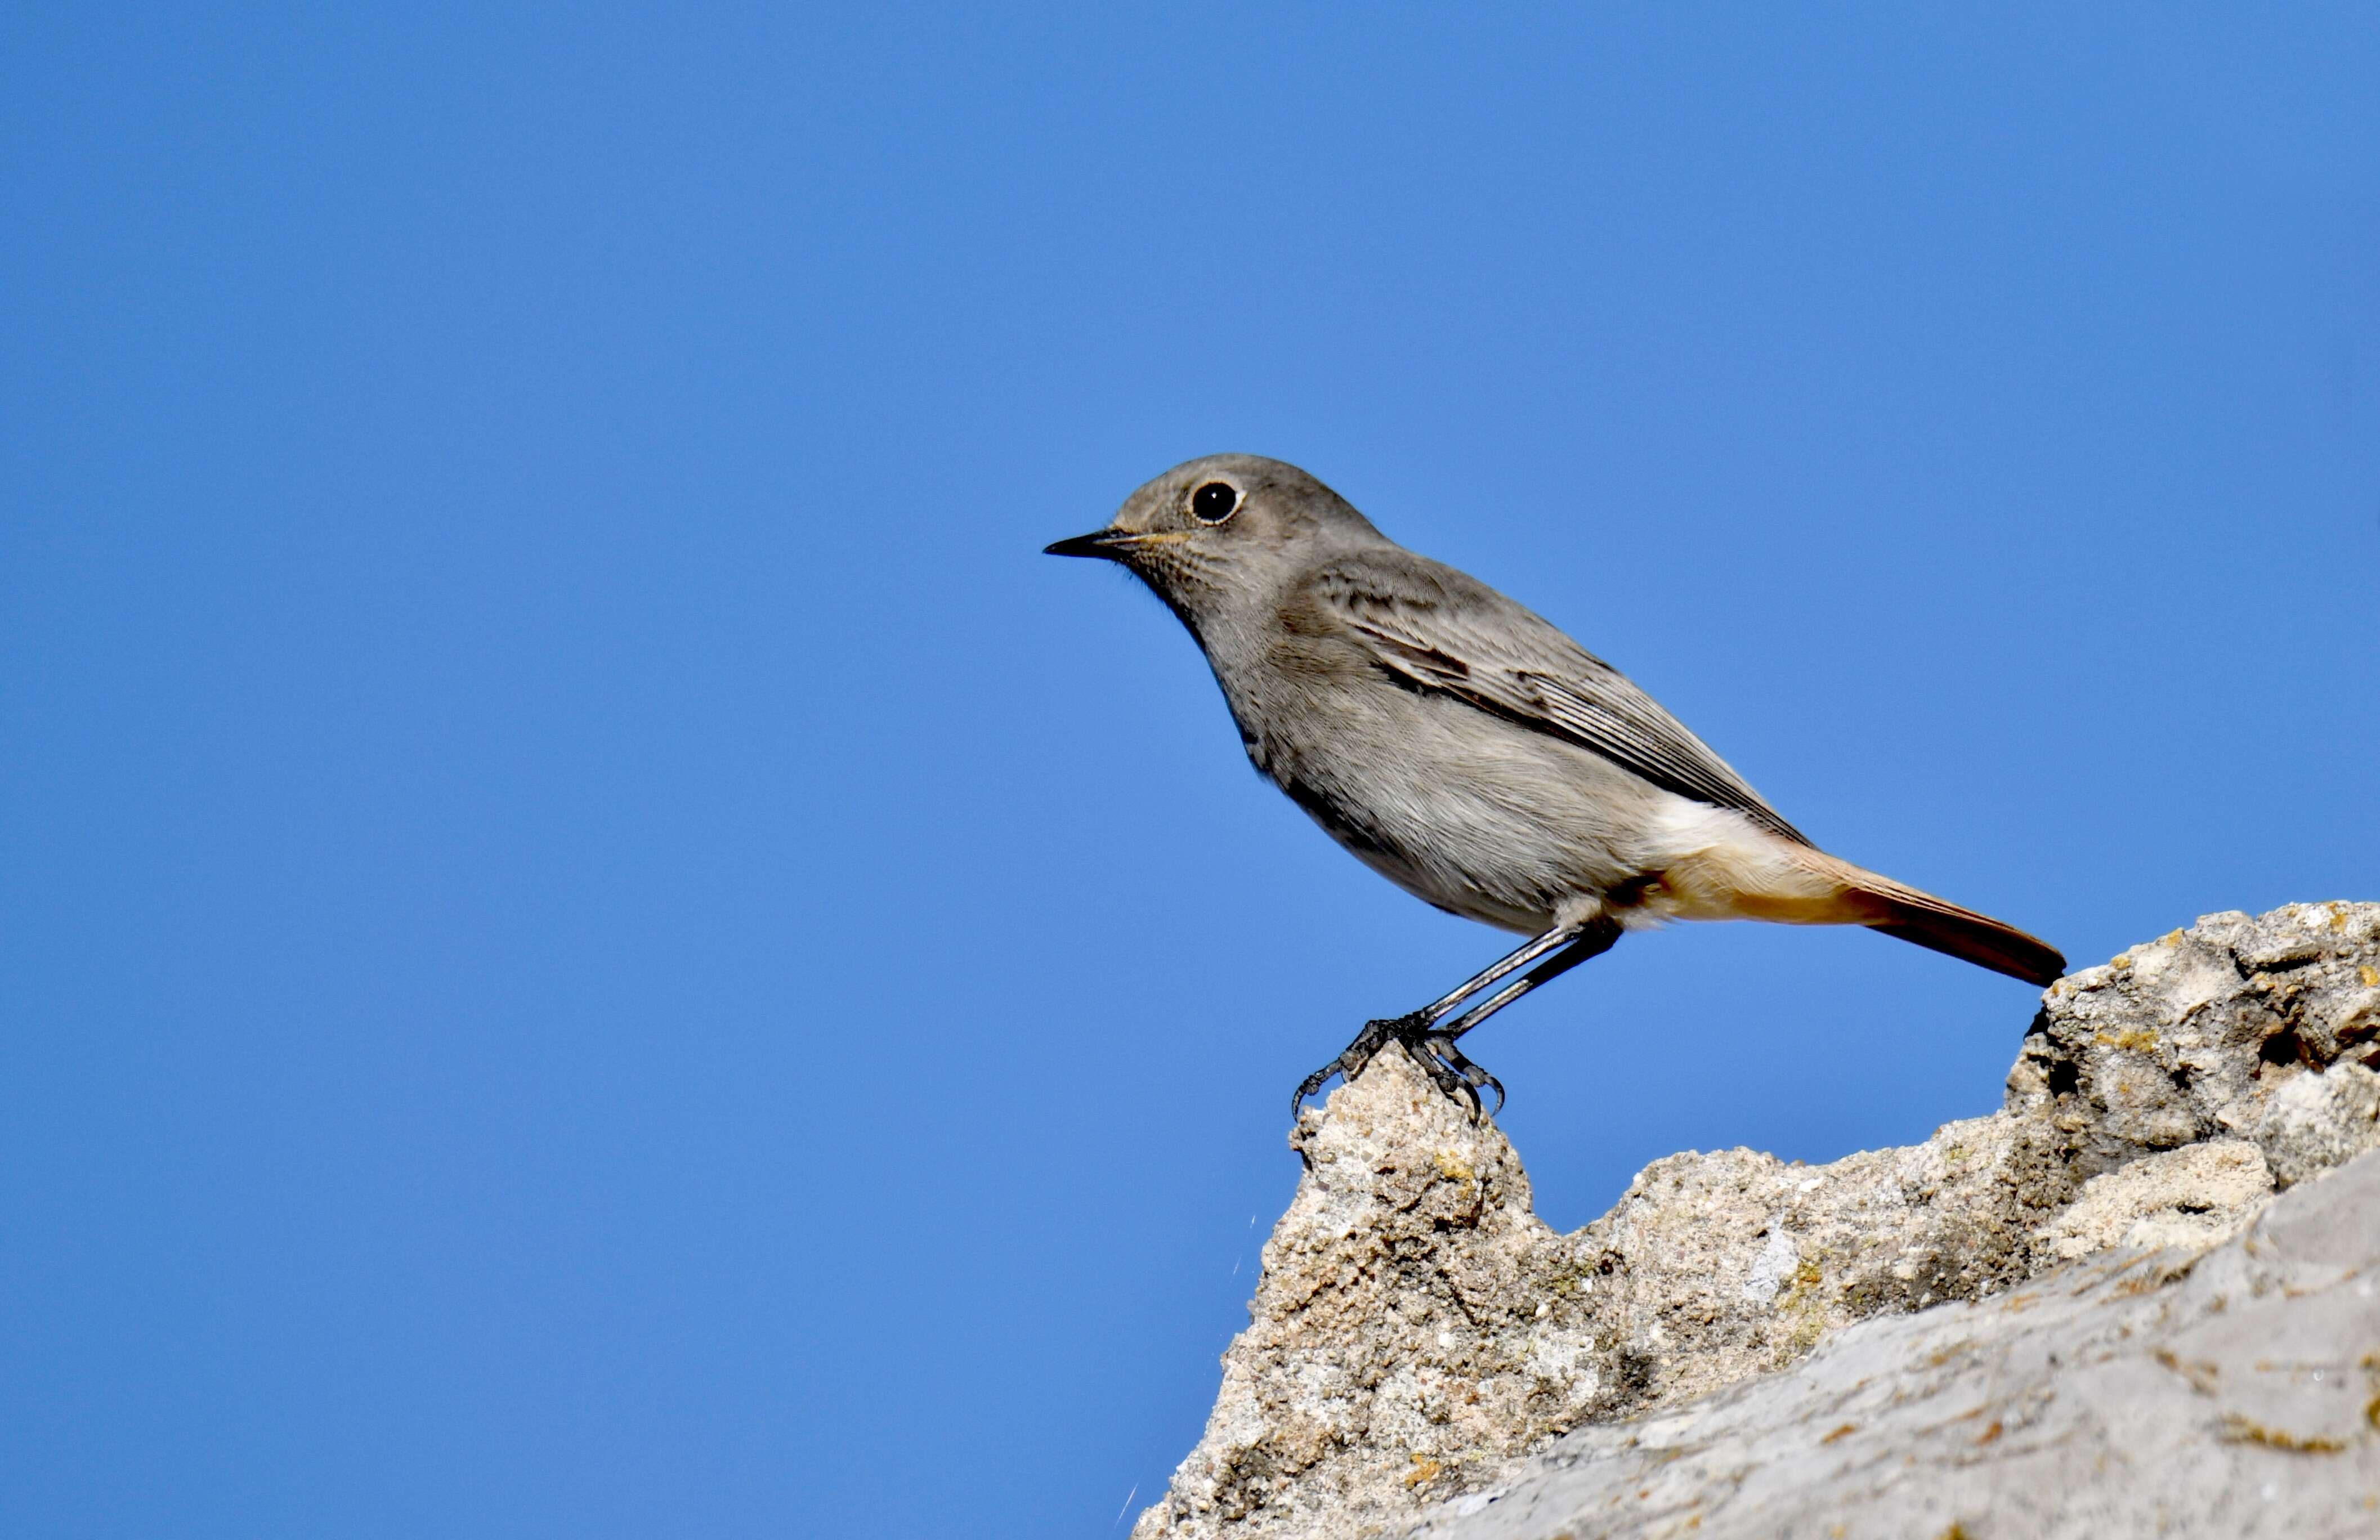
[1250,690,1678,935]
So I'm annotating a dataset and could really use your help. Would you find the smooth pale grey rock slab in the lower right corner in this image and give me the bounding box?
[1399,1152,2380,1540]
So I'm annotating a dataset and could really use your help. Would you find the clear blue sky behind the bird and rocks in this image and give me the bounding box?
[0,5,2380,1540]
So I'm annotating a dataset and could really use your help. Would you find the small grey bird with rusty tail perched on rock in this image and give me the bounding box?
[1045,455,2066,1121]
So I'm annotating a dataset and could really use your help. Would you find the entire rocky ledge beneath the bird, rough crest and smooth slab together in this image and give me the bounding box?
[1133,902,2380,1540]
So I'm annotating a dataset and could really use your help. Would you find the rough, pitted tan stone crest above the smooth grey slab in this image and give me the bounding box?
[1133,905,2380,1540]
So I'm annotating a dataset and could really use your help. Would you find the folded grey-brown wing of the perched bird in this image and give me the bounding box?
[1302,550,1811,845]
